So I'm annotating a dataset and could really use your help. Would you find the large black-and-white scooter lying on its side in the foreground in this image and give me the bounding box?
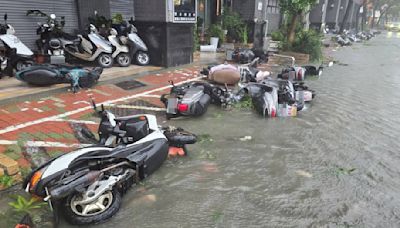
[23,102,196,225]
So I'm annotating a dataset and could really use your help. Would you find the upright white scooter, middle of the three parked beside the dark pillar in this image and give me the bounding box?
[108,28,132,67]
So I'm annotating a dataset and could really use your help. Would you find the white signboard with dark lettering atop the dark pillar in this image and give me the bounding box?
[173,0,197,23]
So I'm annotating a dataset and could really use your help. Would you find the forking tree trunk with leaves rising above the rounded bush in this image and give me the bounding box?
[279,0,317,44]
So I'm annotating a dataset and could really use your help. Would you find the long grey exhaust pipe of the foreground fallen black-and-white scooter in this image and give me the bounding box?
[49,171,102,200]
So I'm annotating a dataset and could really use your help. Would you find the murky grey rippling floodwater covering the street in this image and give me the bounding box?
[61,33,400,228]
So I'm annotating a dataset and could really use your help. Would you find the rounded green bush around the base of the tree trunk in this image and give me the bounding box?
[291,29,322,60]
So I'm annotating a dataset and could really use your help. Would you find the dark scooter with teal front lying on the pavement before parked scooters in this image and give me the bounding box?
[16,64,103,93]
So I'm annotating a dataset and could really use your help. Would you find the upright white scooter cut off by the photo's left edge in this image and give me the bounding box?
[0,14,33,76]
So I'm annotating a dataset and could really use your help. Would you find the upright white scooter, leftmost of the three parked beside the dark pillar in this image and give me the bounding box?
[61,24,114,68]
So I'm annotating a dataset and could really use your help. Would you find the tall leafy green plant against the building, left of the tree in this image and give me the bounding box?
[221,7,245,40]
